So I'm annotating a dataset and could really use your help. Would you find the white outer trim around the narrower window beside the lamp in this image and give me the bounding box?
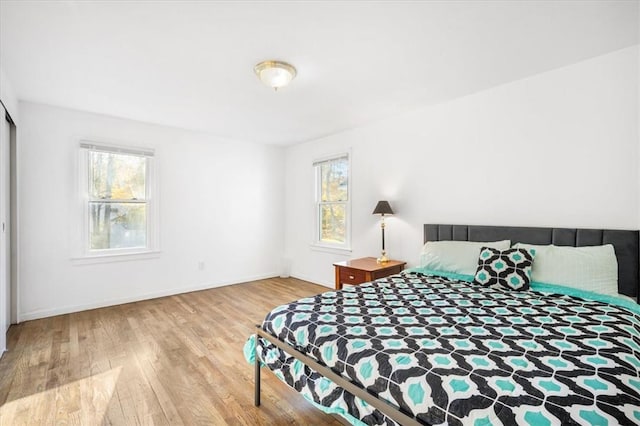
[310,150,353,255]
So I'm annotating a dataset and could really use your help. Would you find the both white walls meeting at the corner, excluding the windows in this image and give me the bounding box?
[12,46,640,321]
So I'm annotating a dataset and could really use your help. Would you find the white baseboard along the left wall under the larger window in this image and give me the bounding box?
[18,272,279,323]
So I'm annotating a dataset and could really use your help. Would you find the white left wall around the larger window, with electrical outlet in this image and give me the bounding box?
[18,102,284,320]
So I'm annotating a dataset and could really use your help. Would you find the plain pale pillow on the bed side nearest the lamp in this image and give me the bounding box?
[420,240,511,275]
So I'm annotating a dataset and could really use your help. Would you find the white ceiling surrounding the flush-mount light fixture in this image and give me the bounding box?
[0,0,640,145]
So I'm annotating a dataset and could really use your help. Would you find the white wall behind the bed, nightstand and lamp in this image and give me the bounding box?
[285,46,640,286]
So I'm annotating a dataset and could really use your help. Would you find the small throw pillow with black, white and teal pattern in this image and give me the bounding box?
[473,247,536,290]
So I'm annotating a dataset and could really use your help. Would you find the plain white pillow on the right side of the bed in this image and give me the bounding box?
[514,243,618,296]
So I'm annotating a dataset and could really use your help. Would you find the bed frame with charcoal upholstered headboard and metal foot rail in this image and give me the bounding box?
[254,224,640,426]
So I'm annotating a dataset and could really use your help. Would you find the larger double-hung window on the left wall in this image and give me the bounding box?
[81,143,155,256]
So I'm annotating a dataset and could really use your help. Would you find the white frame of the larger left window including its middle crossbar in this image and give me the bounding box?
[78,140,159,260]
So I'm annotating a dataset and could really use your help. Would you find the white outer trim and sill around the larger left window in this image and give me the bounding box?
[72,140,160,265]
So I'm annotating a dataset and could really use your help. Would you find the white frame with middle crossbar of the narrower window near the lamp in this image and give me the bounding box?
[311,151,353,253]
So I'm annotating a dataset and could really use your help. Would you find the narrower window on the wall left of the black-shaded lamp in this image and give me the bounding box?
[313,154,351,249]
